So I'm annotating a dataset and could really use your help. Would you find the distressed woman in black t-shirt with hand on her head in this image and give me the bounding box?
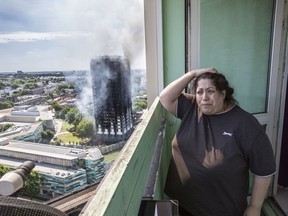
[160,68,275,216]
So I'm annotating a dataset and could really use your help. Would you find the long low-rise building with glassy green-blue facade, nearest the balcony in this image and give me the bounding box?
[0,141,105,198]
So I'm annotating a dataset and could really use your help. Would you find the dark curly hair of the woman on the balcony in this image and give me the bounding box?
[193,72,237,103]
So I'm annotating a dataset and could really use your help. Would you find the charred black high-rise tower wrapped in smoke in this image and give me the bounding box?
[90,56,133,144]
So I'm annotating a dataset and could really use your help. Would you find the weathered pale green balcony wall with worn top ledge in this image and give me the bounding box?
[80,98,171,216]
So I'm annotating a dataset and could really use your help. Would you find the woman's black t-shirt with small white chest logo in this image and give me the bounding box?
[165,95,276,216]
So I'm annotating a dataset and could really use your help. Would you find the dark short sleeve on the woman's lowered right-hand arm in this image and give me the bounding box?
[249,130,276,176]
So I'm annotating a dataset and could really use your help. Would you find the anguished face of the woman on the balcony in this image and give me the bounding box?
[196,79,226,115]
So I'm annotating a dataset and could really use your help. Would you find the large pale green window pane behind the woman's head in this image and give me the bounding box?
[199,0,274,113]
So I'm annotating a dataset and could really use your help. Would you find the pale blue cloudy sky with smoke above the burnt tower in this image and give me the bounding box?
[0,0,146,72]
